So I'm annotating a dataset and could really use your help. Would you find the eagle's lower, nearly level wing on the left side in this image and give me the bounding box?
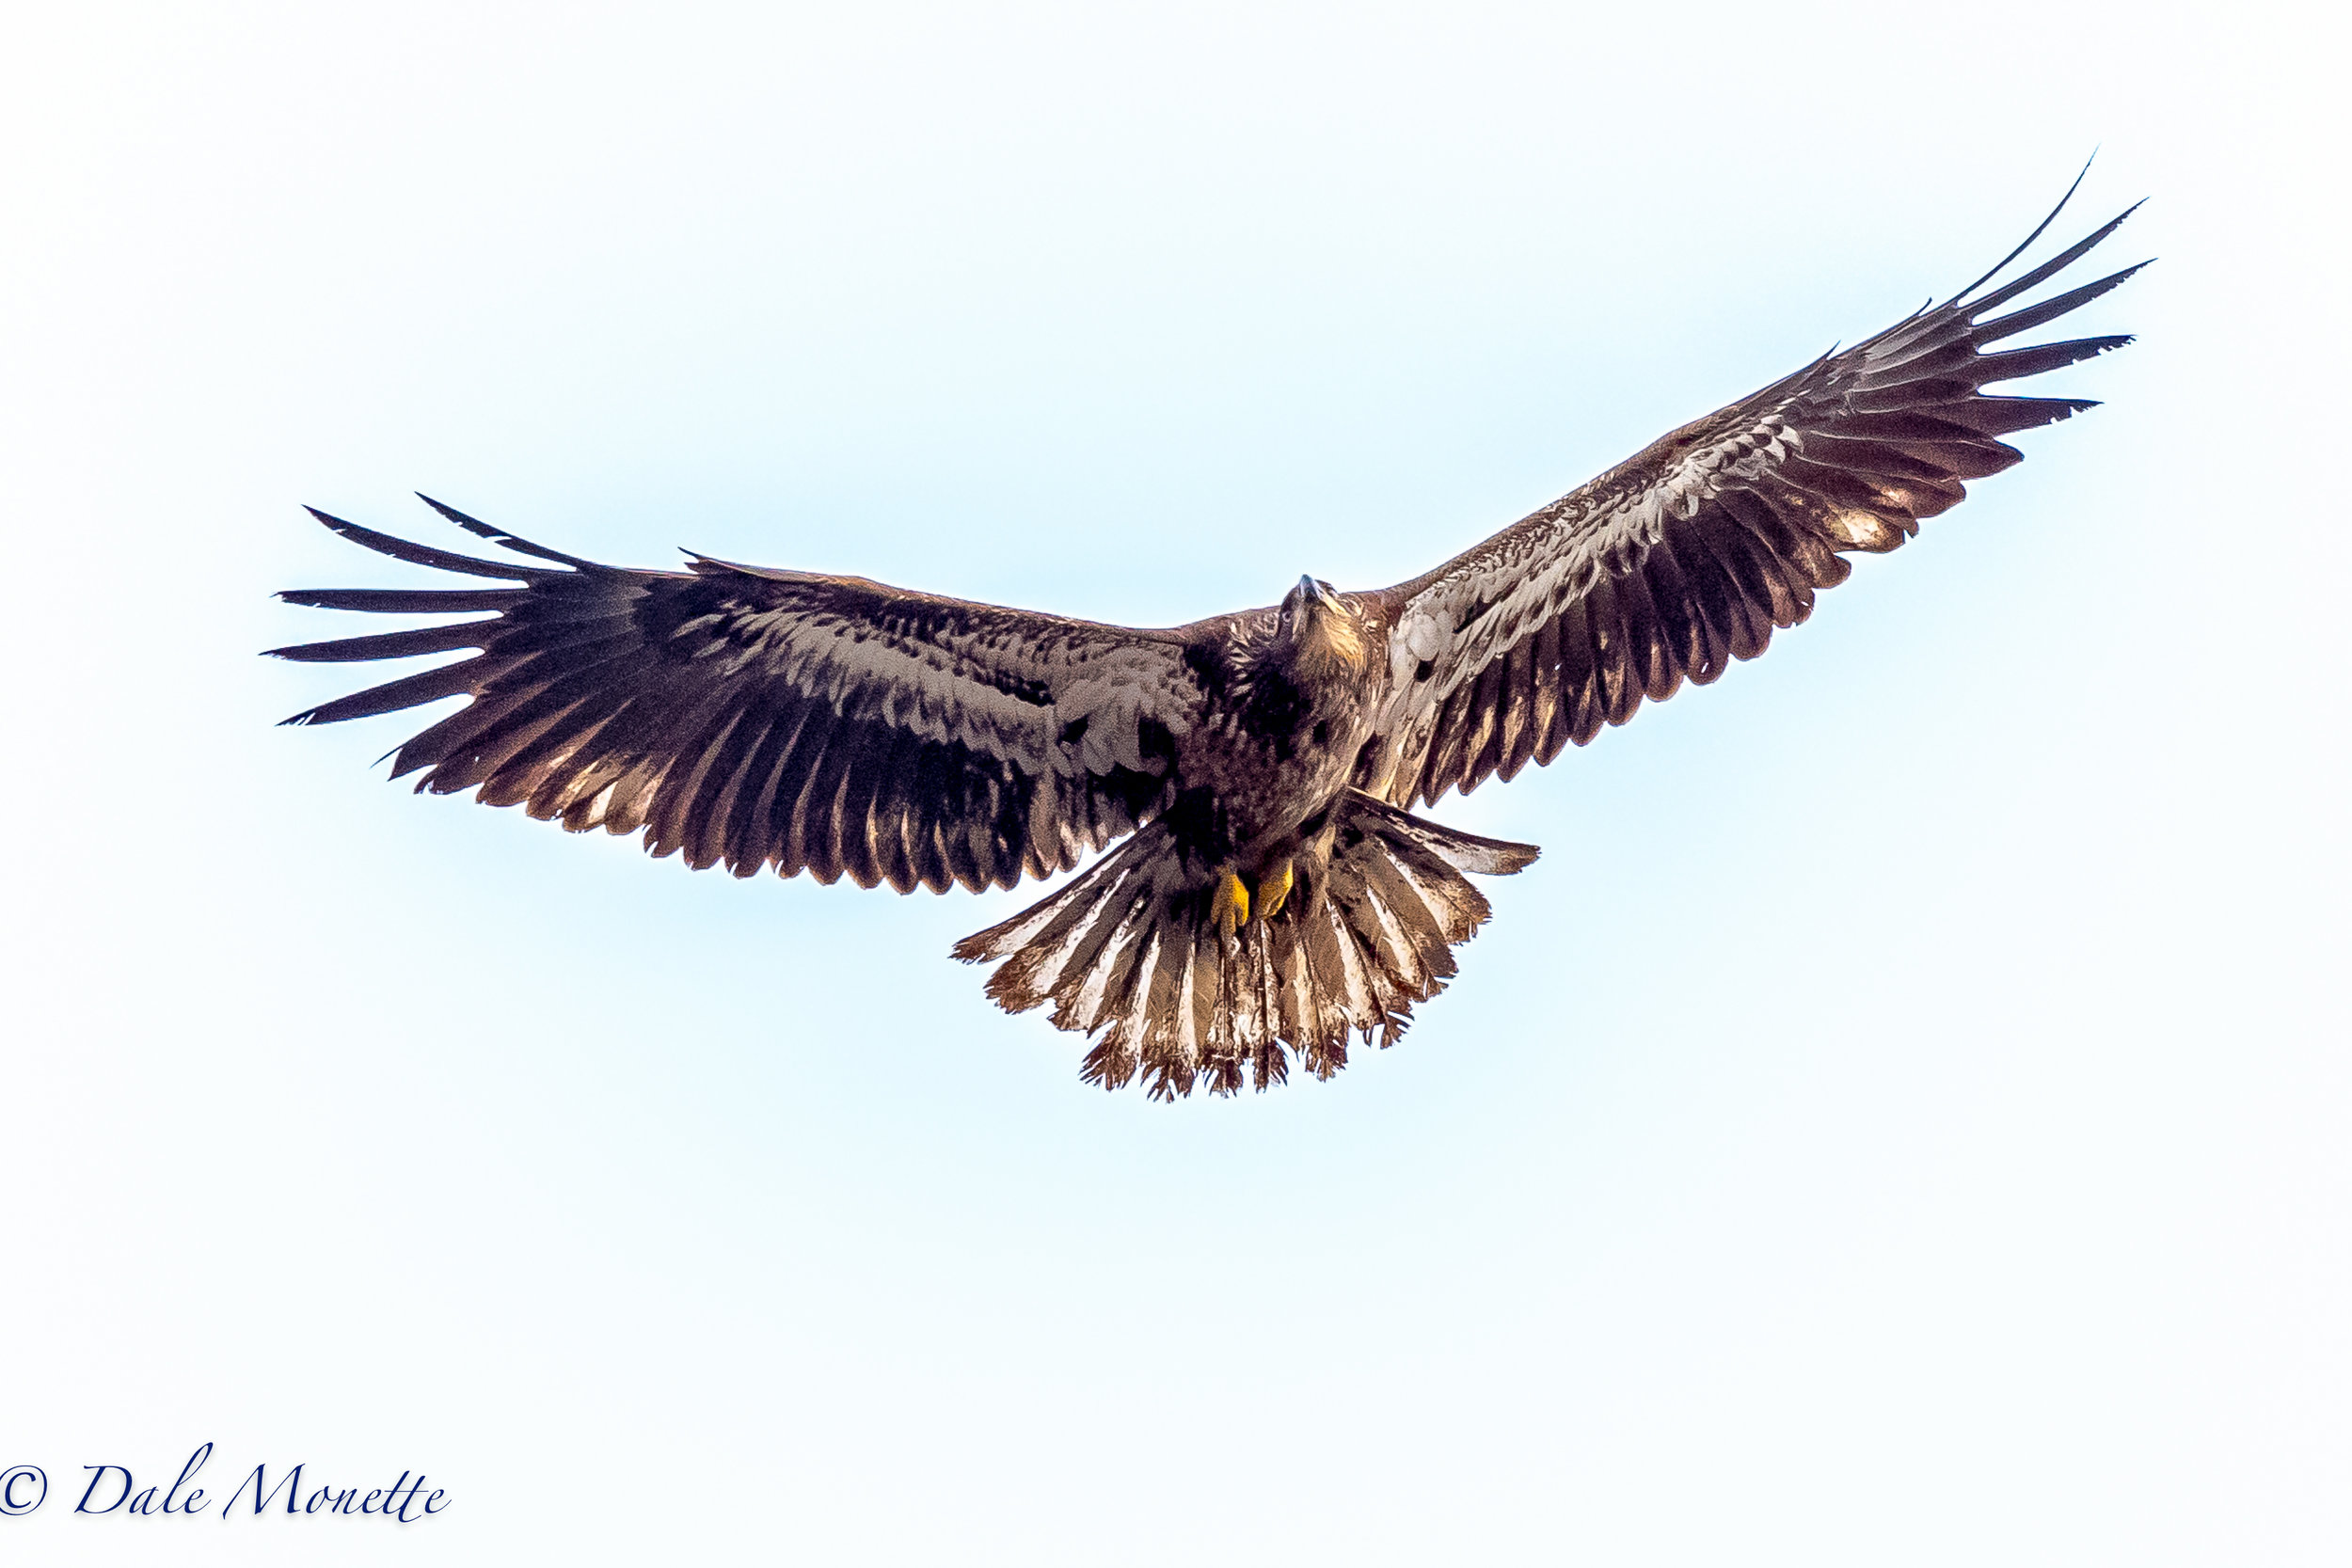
[276,503,1202,891]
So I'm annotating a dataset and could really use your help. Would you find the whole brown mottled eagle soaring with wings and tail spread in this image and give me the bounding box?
[273,176,2148,1101]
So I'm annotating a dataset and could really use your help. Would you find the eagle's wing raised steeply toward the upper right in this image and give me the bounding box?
[1358,190,2145,806]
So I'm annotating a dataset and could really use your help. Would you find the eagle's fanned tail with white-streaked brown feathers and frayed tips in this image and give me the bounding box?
[955,790,1536,1101]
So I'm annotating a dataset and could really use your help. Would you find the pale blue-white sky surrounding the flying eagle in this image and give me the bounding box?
[0,0,2352,1566]
